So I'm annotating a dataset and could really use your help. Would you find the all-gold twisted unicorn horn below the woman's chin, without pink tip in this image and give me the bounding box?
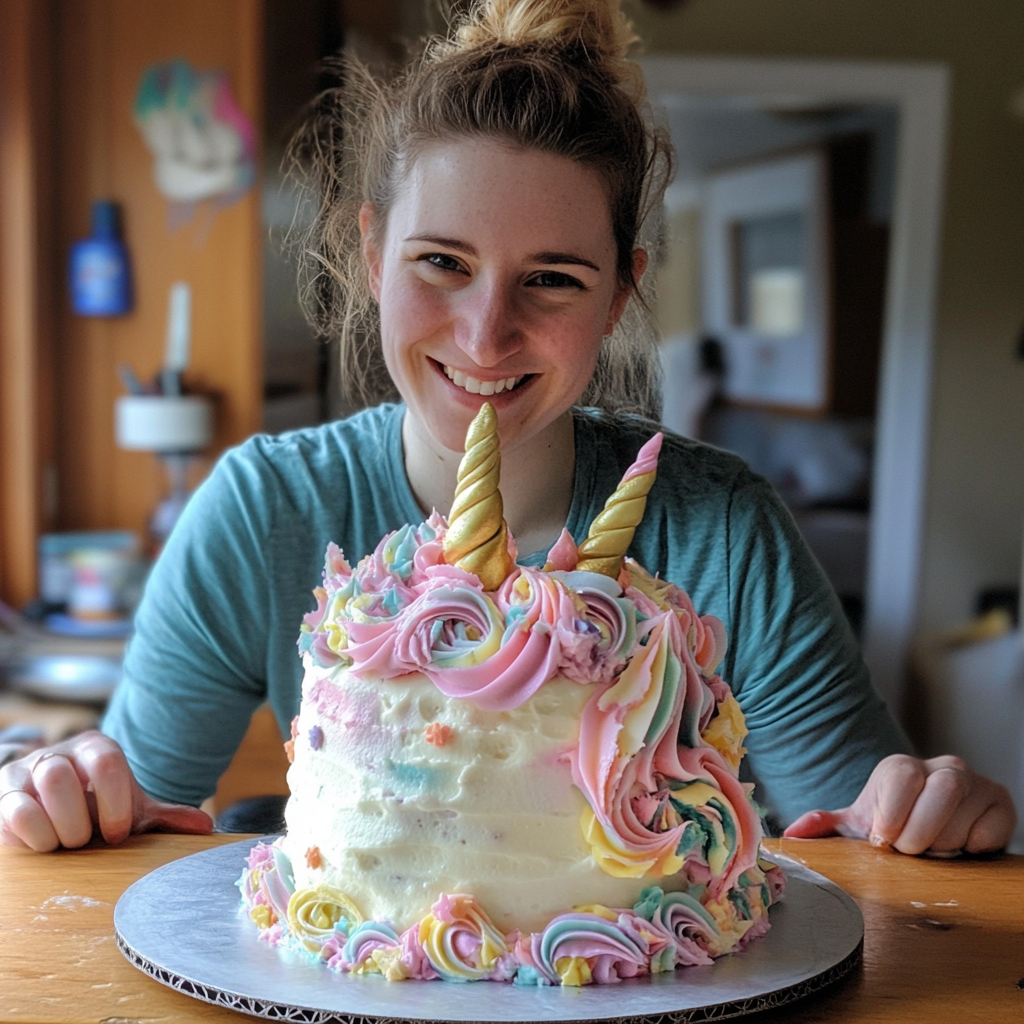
[444,401,514,590]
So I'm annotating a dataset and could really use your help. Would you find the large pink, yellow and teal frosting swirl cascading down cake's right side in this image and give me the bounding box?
[571,610,761,891]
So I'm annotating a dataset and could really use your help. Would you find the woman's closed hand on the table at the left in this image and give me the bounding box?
[0,732,213,853]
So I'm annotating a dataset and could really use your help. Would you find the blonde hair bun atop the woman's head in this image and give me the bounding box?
[448,0,642,90]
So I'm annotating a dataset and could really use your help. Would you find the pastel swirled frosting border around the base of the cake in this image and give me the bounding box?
[238,840,784,986]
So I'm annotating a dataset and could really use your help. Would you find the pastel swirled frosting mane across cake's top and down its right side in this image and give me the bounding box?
[296,513,760,876]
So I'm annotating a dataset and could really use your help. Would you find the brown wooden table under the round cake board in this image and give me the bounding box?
[0,836,1024,1024]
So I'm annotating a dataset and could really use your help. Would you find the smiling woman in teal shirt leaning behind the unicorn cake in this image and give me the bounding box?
[0,0,1014,854]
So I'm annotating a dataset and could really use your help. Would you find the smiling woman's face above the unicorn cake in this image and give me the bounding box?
[361,139,644,452]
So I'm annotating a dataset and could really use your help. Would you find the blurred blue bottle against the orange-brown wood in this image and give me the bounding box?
[69,200,131,316]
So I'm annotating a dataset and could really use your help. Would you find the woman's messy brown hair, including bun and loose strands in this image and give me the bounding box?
[292,0,672,419]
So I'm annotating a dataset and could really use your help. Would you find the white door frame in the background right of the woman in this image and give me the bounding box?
[642,55,948,714]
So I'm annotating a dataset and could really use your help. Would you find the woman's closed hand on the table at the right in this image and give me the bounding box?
[782,754,1017,857]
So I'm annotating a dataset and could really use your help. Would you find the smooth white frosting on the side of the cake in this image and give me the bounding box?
[285,656,685,932]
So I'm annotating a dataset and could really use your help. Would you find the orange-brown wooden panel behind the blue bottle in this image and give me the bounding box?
[54,0,263,532]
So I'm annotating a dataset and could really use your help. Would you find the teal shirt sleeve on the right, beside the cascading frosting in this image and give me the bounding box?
[726,472,911,825]
